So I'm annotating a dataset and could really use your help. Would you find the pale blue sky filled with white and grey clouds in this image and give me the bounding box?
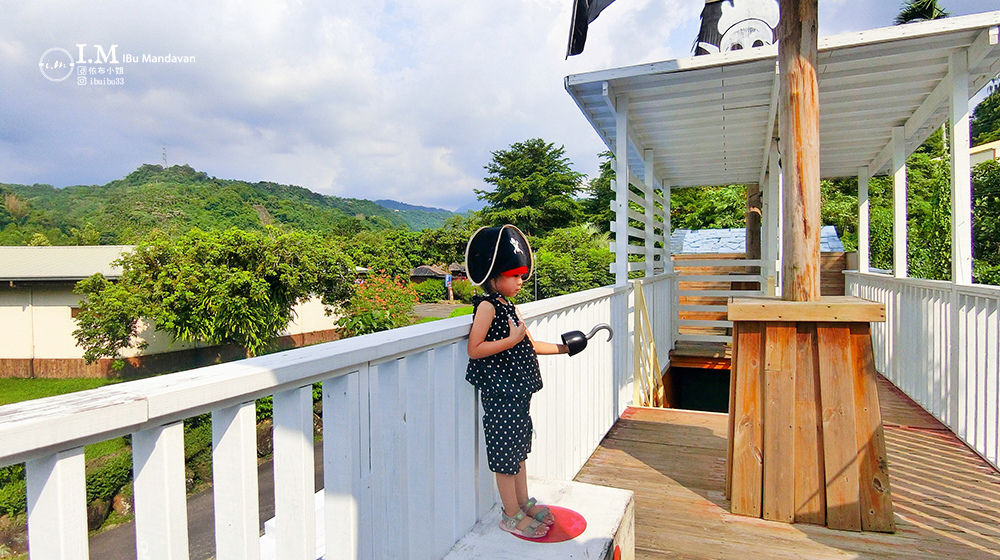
[0,0,1000,210]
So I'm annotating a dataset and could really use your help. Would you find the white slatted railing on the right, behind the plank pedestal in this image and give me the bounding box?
[845,272,1000,467]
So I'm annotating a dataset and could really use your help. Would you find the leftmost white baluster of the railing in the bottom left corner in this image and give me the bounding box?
[25,447,90,560]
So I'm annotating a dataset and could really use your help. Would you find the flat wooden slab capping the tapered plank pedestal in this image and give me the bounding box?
[729,296,885,323]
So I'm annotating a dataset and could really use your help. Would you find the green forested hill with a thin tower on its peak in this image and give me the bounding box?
[0,165,451,245]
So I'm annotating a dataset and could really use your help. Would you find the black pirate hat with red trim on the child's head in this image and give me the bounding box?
[465,224,534,286]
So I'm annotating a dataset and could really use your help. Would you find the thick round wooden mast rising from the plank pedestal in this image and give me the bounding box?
[778,0,821,301]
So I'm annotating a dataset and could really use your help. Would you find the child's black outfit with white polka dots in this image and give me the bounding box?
[465,294,542,474]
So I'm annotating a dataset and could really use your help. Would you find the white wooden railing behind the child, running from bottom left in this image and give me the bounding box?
[0,283,636,559]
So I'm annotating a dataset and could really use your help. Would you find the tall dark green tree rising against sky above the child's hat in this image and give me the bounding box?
[476,138,583,236]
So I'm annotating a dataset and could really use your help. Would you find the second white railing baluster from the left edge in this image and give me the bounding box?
[132,422,188,560]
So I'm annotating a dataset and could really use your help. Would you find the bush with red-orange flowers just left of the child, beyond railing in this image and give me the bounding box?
[337,274,419,336]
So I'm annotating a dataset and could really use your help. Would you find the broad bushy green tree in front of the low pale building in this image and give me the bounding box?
[73,228,354,361]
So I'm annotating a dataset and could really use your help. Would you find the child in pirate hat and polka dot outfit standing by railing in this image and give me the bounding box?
[465,225,569,539]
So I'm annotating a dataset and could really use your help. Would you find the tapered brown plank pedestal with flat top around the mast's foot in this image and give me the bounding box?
[726,296,895,532]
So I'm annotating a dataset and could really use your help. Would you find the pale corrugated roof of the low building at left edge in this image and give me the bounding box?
[0,245,133,282]
